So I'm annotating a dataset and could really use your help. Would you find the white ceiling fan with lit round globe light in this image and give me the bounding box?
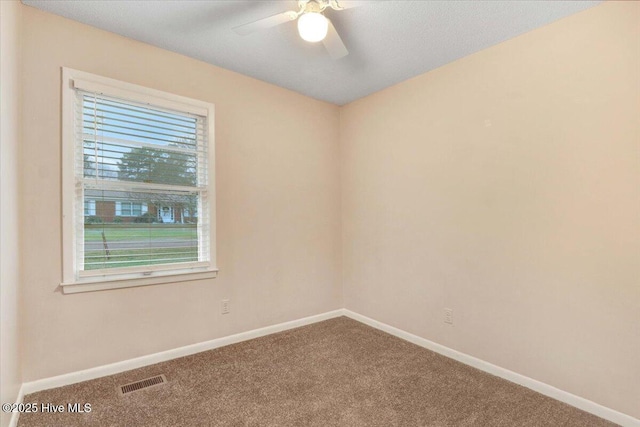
[233,0,356,59]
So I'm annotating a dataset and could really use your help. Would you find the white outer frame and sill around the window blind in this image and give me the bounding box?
[61,67,218,294]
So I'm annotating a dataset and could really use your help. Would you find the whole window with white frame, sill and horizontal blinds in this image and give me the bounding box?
[62,68,217,293]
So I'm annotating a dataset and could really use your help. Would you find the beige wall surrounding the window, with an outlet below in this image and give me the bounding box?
[21,7,341,381]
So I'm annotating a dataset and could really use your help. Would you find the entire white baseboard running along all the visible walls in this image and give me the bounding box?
[9,309,640,427]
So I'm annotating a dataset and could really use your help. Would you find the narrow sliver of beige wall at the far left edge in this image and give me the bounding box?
[0,1,22,427]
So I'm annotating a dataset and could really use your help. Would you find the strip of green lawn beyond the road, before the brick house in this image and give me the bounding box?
[84,224,198,242]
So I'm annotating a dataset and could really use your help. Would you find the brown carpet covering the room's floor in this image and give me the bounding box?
[19,317,613,427]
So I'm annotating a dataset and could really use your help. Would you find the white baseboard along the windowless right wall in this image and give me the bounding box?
[343,309,640,427]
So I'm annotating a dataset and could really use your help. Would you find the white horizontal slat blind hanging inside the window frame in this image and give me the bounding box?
[74,89,209,276]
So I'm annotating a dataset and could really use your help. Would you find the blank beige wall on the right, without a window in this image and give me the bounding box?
[340,2,640,417]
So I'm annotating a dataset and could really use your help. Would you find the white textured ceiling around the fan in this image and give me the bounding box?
[23,0,599,105]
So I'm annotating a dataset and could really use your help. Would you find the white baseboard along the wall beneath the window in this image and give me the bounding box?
[20,309,344,396]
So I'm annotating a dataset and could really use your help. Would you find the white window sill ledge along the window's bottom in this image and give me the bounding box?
[60,269,218,294]
